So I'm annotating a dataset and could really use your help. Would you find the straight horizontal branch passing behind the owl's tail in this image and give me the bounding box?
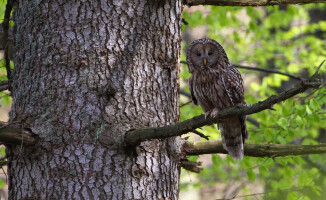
[183,140,326,158]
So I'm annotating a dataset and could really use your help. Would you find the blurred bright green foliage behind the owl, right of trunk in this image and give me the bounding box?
[180,4,326,200]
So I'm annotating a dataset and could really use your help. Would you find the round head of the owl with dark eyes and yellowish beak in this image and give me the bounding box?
[187,38,229,73]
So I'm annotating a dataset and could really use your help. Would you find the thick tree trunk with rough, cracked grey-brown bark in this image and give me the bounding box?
[7,0,182,199]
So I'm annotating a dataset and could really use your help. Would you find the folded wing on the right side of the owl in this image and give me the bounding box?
[221,66,249,143]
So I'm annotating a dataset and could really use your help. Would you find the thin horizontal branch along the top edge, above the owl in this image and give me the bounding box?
[184,0,325,6]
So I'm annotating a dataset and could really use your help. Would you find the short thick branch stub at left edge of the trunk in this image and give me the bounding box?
[0,123,37,146]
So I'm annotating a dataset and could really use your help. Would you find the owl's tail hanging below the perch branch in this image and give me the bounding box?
[219,117,248,160]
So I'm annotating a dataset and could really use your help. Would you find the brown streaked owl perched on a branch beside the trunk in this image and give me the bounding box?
[187,38,249,160]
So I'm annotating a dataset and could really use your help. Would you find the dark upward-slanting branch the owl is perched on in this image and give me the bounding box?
[125,61,325,146]
